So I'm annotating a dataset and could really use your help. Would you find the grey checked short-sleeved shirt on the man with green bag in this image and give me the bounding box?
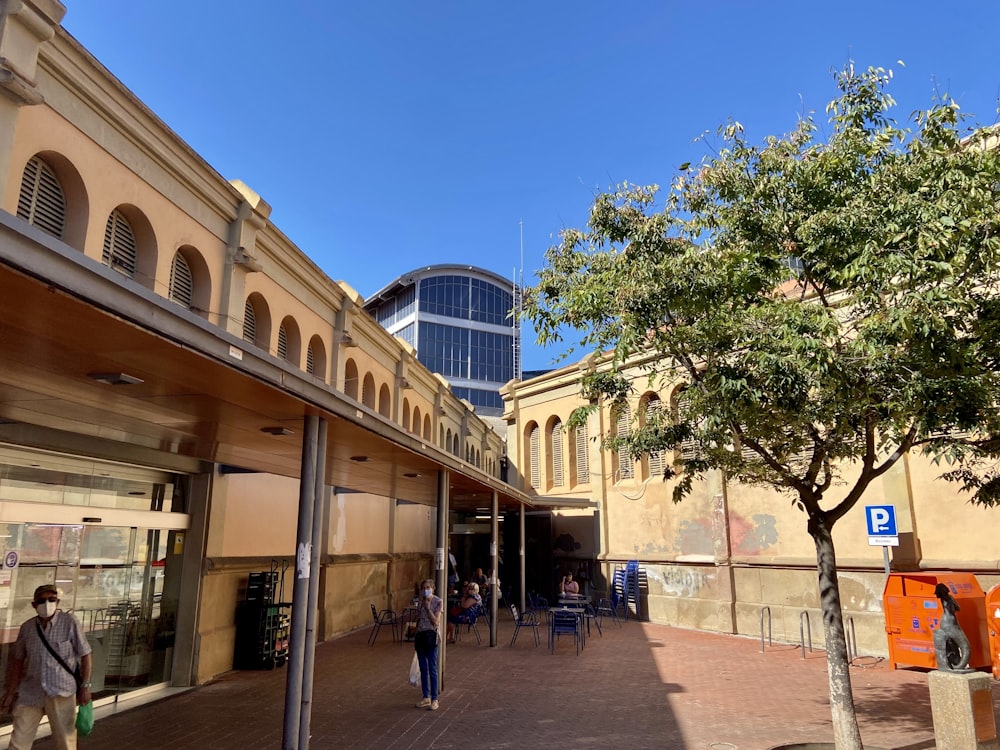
[14,610,91,706]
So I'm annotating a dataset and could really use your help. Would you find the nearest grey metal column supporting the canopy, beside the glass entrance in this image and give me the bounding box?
[281,416,319,750]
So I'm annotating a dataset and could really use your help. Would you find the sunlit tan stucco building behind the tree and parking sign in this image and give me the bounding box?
[504,346,1000,656]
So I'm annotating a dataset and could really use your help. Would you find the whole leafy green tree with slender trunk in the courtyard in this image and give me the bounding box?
[524,65,1000,750]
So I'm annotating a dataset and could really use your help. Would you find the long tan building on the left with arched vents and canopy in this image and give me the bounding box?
[0,0,533,720]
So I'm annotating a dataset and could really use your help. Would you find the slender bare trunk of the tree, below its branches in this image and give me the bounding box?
[809,518,862,750]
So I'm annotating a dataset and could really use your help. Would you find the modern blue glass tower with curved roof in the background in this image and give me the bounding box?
[365,264,521,417]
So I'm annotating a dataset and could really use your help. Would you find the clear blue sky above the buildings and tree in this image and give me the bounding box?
[63,0,1000,369]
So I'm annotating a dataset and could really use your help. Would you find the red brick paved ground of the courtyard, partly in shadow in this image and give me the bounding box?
[19,620,1000,750]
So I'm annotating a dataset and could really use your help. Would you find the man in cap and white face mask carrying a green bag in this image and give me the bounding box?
[0,584,92,750]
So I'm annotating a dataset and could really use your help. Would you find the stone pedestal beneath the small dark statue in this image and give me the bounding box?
[927,669,1000,750]
